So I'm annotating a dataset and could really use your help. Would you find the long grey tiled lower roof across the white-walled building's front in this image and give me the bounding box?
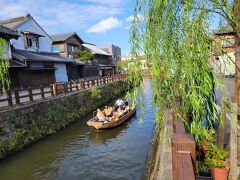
[12,49,73,63]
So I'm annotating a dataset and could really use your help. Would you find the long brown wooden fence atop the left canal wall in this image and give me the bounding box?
[0,74,124,107]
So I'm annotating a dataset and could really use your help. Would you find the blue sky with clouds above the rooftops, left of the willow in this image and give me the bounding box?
[0,0,135,56]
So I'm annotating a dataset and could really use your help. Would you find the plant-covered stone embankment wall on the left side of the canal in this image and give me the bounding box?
[0,82,127,158]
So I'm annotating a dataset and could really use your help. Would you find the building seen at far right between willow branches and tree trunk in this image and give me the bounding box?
[210,26,235,75]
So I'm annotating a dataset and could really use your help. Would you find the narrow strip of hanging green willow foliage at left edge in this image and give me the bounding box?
[0,38,10,93]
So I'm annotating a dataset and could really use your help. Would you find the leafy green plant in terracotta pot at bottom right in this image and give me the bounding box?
[206,144,229,180]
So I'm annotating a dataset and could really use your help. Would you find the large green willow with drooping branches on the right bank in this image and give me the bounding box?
[128,0,240,177]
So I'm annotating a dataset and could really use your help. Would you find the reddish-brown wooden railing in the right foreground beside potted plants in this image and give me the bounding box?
[172,118,196,180]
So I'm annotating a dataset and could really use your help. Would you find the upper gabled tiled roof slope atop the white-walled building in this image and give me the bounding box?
[0,14,32,29]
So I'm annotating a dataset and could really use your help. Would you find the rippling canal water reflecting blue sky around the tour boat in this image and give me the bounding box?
[0,79,155,180]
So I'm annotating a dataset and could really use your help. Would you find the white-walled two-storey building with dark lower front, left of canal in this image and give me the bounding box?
[0,14,71,89]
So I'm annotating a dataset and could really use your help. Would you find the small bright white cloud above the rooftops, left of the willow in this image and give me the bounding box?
[87,17,122,33]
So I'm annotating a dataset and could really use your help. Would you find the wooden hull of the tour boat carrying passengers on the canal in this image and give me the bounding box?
[87,105,136,129]
